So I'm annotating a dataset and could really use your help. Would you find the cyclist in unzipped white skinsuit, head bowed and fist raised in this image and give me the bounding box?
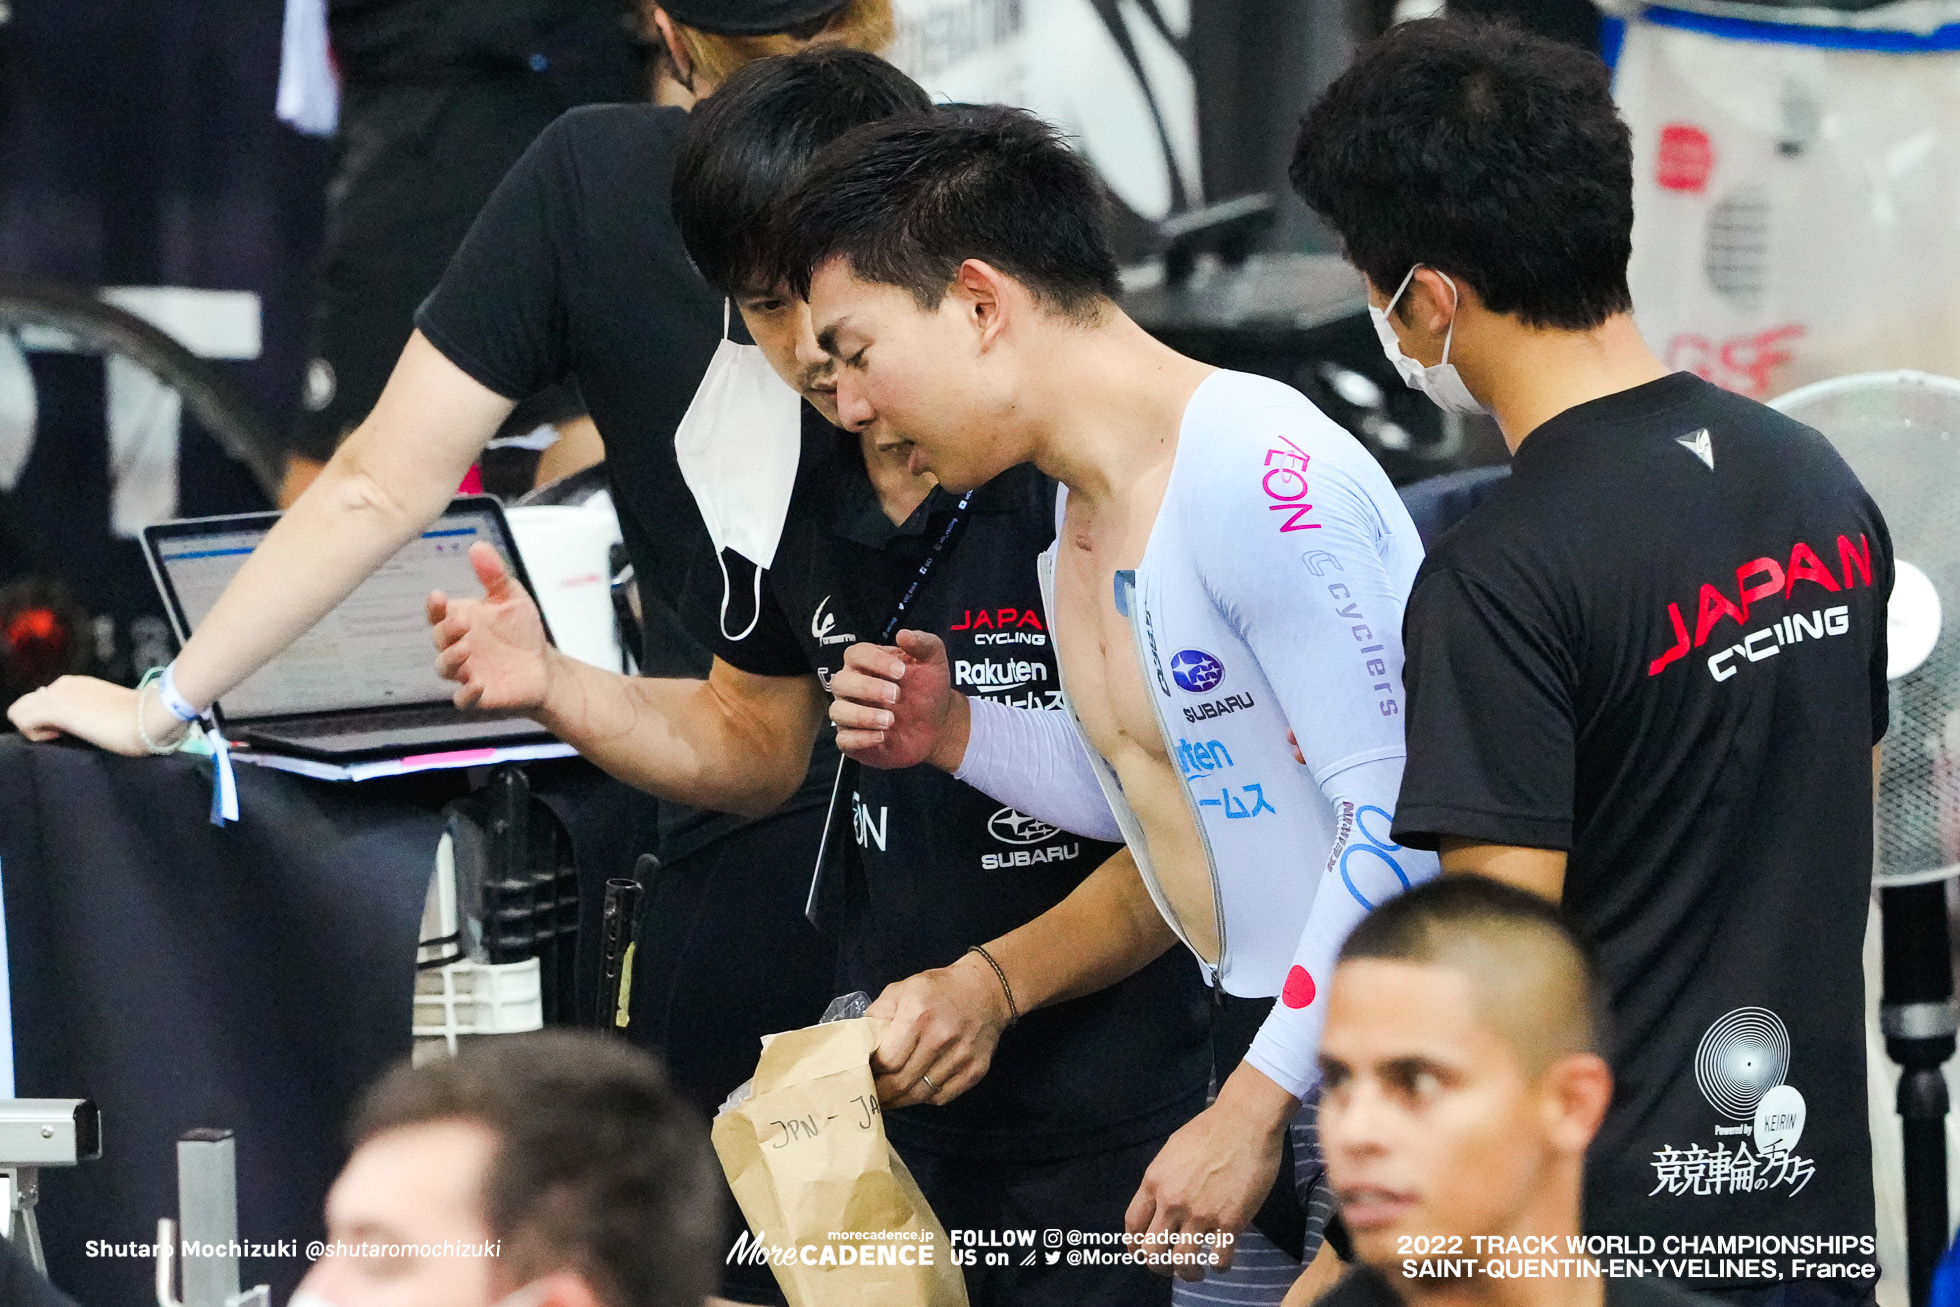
[784,108,1437,1305]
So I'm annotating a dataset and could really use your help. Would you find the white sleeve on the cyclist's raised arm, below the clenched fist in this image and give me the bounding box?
[953,696,1123,841]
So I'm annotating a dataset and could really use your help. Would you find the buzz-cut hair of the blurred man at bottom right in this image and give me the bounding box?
[1341,874,1607,1052]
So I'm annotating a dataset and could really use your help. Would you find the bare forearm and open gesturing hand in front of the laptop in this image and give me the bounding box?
[429,543,823,817]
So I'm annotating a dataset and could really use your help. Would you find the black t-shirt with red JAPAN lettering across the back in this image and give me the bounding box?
[1396,372,1891,1285]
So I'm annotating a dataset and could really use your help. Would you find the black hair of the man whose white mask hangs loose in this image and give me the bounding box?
[674,45,933,292]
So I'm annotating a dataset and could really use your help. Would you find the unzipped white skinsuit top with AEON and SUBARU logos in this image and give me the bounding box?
[956,372,1439,1136]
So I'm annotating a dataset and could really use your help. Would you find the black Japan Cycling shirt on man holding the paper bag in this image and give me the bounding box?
[698,408,1211,1160]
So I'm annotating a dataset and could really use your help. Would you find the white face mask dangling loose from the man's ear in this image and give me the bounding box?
[674,302,804,641]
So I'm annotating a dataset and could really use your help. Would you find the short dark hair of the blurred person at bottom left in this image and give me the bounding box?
[349,1031,721,1307]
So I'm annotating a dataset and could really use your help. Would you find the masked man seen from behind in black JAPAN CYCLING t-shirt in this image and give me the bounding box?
[1292,20,1891,1305]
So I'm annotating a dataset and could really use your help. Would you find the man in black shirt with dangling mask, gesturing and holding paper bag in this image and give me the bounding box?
[431,51,1209,1307]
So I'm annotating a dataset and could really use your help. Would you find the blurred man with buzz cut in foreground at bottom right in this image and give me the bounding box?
[1317,876,1707,1307]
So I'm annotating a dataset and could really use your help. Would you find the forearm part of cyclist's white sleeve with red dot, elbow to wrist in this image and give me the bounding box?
[1245,758,1443,1097]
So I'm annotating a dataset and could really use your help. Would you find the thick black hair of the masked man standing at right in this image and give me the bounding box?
[1288,18,1633,331]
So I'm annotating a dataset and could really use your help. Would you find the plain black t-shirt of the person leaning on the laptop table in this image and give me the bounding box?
[416,104,837,862]
